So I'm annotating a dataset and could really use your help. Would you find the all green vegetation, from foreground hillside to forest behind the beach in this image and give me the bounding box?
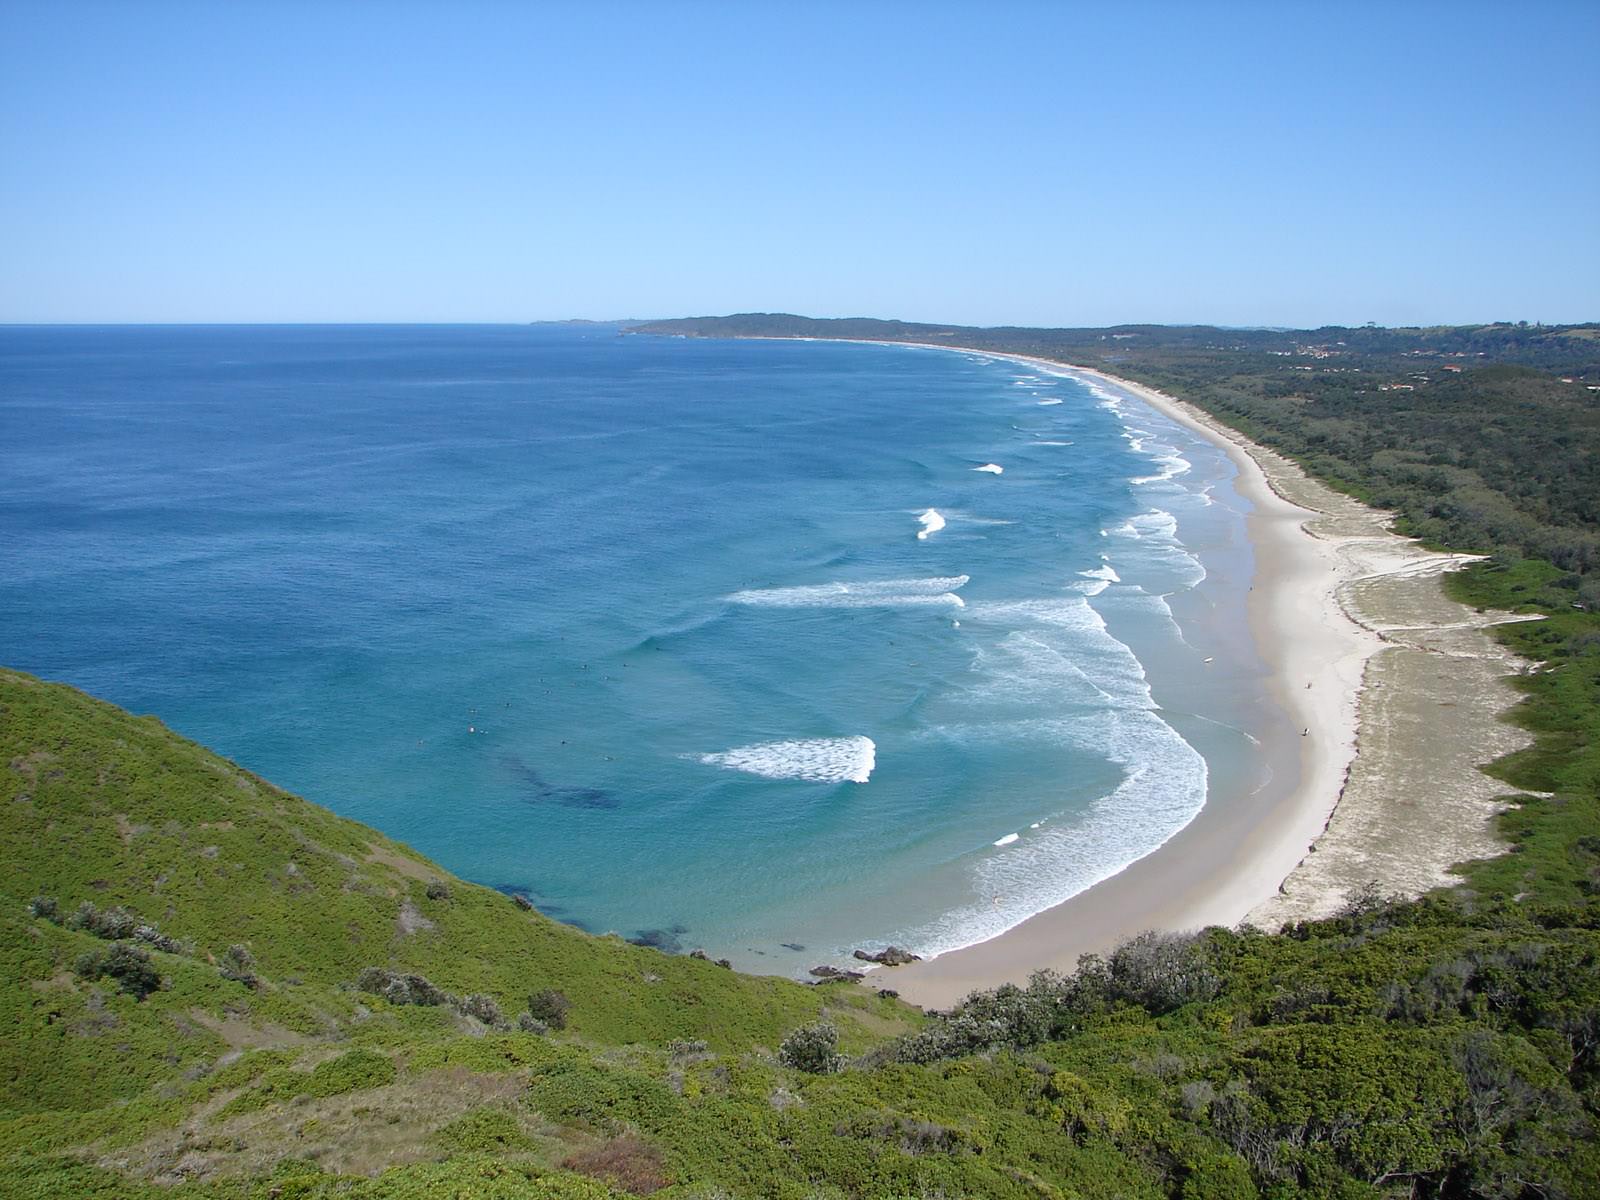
[0,318,1600,1200]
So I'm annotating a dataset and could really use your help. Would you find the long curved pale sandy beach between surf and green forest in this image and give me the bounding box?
[825,342,1528,1008]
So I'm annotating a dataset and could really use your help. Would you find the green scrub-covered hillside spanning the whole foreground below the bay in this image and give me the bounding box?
[9,633,1600,1200]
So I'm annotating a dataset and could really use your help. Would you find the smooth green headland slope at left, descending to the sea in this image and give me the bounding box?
[0,670,910,1196]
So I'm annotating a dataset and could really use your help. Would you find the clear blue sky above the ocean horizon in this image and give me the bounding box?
[0,0,1600,325]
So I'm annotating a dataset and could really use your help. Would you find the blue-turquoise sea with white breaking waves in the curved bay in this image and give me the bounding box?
[0,326,1282,973]
